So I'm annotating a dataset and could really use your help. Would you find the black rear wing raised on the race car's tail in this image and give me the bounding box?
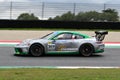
[95,31,108,41]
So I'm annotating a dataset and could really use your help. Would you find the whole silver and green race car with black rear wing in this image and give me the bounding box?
[14,31,108,57]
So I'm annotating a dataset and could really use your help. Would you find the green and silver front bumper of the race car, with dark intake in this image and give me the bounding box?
[14,47,29,55]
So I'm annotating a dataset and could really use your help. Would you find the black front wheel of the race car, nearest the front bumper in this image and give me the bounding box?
[29,43,44,57]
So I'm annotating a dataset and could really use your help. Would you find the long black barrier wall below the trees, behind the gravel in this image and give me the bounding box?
[0,20,120,30]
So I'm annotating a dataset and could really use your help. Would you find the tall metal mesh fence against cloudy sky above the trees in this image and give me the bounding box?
[0,2,120,19]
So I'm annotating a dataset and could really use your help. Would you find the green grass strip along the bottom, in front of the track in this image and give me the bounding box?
[0,69,120,80]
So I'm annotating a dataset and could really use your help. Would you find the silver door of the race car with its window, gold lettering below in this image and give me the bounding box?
[54,33,76,52]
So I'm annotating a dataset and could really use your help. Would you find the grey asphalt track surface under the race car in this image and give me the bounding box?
[0,47,120,67]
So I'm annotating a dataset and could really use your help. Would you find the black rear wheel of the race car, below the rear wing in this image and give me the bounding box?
[79,44,94,57]
